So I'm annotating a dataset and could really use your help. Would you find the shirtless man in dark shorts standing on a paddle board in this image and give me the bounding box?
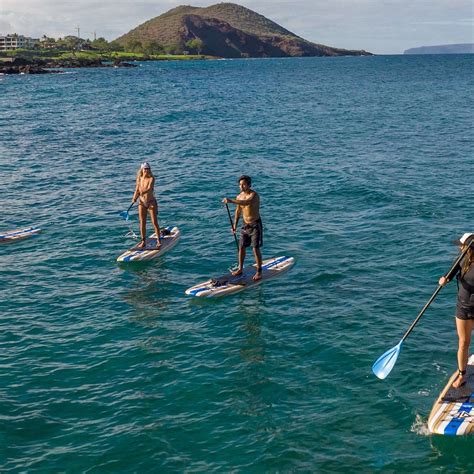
[222,175,263,281]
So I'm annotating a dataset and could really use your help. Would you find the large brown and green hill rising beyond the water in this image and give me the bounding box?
[115,3,371,58]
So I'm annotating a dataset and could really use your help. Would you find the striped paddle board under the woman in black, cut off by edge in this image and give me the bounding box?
[428,354,474,436]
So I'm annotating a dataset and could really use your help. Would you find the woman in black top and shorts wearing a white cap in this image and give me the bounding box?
[439,233,474,388]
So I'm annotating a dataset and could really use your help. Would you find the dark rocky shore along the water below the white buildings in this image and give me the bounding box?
[0,58,136,74]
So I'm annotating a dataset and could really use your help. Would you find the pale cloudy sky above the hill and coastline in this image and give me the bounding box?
[0,0,474,54]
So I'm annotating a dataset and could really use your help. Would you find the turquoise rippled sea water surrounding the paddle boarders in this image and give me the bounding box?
[0,56,474,472]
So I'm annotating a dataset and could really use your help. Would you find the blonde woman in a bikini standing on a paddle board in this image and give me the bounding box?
[132,163,161,249]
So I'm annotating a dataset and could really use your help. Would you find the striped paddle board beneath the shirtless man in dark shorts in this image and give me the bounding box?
[185,257,295,298]
